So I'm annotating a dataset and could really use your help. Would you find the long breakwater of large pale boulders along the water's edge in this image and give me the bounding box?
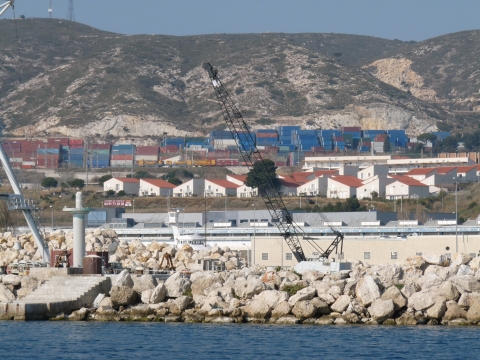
[70,254,480,325]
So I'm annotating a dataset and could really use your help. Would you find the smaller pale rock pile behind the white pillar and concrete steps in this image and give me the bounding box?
[0,229,245,271]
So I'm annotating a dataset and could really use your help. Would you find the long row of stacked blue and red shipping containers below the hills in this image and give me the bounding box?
[2,126,464,169]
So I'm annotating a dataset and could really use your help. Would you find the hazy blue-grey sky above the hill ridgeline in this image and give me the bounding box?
[0,0,480,40]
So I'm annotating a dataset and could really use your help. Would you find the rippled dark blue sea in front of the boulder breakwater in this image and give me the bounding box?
[0,321,480,360]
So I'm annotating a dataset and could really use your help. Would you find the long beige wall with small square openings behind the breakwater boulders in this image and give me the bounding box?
[252,235,480,266]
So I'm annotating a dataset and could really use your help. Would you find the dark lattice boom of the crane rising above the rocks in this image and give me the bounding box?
[204,63,306,262]
